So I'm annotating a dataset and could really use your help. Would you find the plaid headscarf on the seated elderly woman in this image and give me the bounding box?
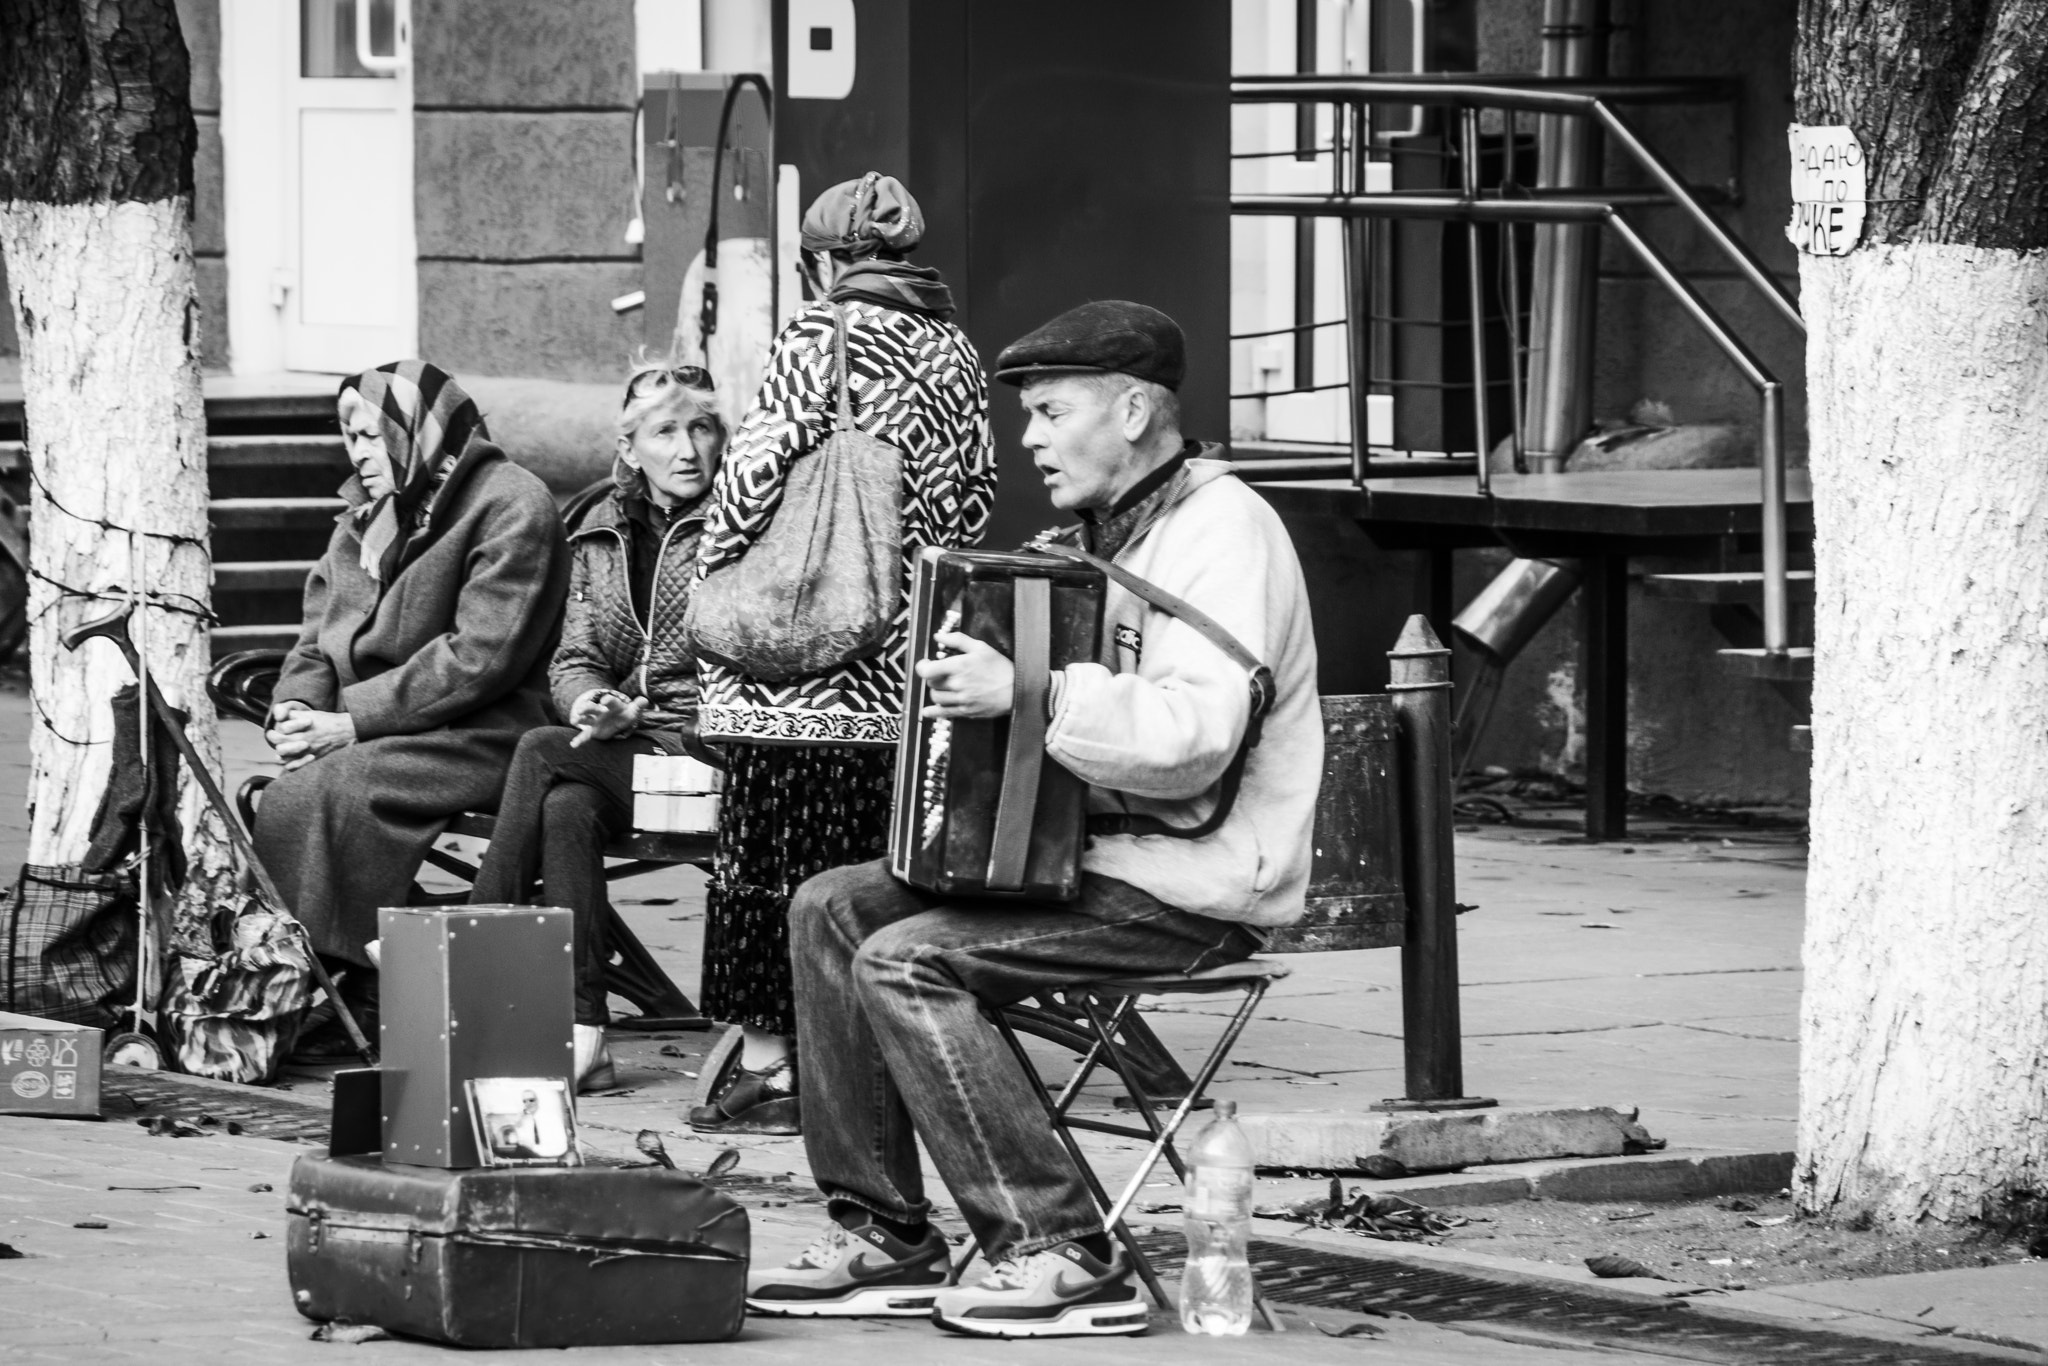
[336,360,489,584]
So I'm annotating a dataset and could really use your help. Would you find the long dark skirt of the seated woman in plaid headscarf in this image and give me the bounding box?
[256,729,518,967]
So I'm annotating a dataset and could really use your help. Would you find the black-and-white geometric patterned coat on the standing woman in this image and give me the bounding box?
[698,299,995,745]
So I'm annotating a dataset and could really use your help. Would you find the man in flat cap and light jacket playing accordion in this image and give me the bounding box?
[748,301,1323,1337]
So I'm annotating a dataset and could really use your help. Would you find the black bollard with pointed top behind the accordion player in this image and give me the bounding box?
[1386,616,1493,1110]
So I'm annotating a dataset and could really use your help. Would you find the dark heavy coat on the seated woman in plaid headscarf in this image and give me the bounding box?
[274,440,569,739]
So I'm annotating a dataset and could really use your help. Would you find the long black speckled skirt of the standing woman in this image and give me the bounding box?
[700,743,895,1038]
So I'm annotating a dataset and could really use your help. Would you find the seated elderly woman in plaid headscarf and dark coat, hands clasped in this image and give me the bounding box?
[256,360,569,1051]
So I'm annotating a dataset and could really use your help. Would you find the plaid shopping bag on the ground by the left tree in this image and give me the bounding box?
[0,864,137,1028]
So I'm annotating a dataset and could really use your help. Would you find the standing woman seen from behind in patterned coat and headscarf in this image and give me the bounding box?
[690,172,995,1133]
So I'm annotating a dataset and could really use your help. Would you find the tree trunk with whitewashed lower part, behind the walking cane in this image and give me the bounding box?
[0,0,227,962]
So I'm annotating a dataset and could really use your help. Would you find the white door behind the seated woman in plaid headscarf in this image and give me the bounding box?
[279,0,418,373]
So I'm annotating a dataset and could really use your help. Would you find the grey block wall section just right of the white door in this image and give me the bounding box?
[414,0,641,381]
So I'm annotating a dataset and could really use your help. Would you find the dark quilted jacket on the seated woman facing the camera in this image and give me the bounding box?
[549,489,705,731]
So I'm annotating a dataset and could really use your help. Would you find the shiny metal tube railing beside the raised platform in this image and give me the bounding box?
[1231,76,1806,653]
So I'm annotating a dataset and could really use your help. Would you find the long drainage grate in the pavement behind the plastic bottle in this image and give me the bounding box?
[1139,1233,1985,1366]
